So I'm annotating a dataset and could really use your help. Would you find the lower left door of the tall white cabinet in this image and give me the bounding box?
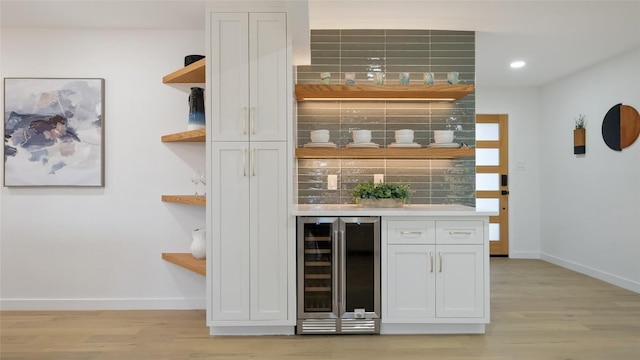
[207,142,250,320]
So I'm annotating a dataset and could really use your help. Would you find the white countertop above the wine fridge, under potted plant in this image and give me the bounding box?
[292,204,498,217]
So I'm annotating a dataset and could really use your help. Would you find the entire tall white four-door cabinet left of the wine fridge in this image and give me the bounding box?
[207,5,295,335]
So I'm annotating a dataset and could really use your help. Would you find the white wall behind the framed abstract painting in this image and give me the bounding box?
[0,29,205,310]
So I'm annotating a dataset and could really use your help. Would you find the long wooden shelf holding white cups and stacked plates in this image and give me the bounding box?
[296,148,476,159]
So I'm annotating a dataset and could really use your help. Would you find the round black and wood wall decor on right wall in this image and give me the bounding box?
[602,104,640,151]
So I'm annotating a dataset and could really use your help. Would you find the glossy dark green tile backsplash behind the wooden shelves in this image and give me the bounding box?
[297,30,475,206]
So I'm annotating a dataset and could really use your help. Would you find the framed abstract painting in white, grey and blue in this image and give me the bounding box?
[4,78,104,186]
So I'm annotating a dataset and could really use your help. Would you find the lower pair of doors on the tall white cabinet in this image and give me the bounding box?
[207,142,292,327]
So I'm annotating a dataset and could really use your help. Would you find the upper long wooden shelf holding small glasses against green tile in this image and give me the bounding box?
[296,84,475,101]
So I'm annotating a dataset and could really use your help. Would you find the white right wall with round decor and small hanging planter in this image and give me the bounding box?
[540,48,640,292]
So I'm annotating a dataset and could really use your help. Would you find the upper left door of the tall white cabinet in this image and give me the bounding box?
[206,13,250,141]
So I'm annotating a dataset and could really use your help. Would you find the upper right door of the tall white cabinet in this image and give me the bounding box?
[249,13,291,141]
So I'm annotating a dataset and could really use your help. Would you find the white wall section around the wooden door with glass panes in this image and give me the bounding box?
[476,84,540,259]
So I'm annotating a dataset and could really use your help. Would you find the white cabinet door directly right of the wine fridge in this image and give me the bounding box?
[384,245,435,319]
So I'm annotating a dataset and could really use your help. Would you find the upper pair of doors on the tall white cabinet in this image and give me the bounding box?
[207,12,290,141]
